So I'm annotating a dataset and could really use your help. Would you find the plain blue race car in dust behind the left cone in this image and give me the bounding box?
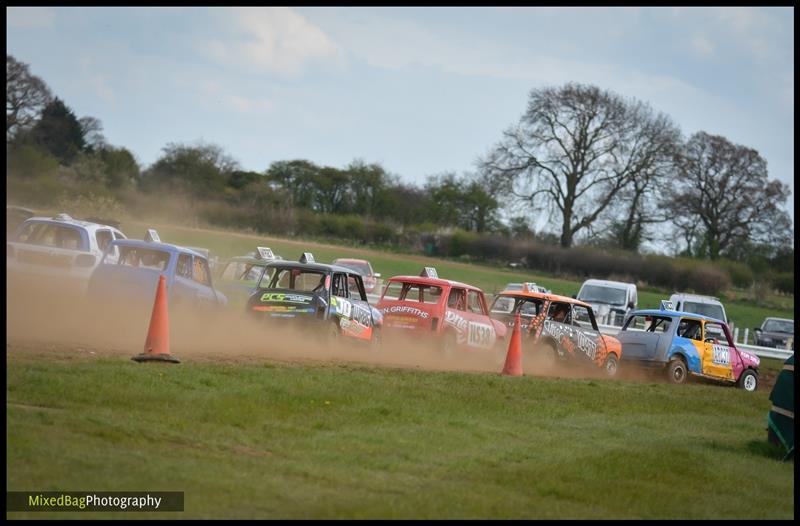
[87,239,228,312]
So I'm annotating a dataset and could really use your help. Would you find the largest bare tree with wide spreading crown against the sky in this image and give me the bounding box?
[480,83,677,247]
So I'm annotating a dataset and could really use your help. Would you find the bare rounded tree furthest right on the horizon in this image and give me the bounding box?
[663,132,793,259]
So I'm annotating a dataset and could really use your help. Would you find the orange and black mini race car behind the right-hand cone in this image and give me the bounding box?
[491,286,622,376]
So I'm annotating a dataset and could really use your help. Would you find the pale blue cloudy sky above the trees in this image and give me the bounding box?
[6,7,794,227]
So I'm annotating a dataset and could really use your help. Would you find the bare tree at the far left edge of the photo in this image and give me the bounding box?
[6,55,53,143]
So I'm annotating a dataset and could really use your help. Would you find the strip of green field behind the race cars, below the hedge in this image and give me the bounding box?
[122,221,794,343]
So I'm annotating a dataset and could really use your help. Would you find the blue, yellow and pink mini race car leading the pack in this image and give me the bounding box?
[617,302,760,391]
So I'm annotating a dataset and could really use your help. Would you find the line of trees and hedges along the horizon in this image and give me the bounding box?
[6,55,794,294]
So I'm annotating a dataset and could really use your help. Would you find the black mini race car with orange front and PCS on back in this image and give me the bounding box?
[246,252,383,344]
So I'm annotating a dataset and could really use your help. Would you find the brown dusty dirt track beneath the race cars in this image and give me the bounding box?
[6,276,774,389]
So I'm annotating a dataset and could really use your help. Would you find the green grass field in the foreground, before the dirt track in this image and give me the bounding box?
[6,345,794,519]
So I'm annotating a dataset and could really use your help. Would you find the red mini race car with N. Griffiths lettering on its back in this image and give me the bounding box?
[377,267,507,355]
